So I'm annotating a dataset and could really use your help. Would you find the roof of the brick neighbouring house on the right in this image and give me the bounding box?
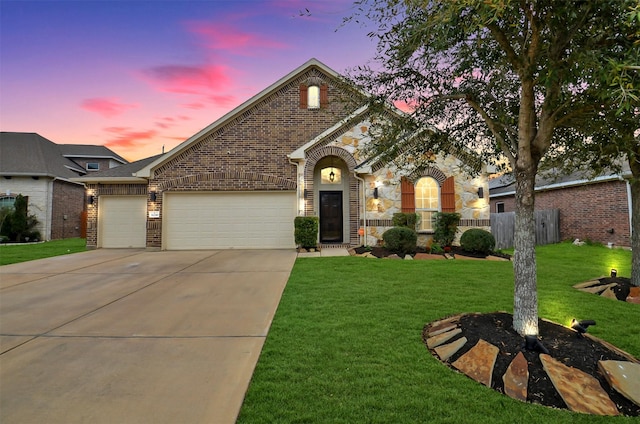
[489,164,631,197]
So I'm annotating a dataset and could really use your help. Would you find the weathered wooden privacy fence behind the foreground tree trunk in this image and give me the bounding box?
[491,209,560,249]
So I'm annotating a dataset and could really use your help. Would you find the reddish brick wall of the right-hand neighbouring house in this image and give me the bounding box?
[491,180,631,246]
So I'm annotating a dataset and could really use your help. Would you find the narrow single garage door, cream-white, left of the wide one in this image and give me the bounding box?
[98,196,147,248]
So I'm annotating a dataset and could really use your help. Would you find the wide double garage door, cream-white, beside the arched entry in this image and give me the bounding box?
[162,192,296,250]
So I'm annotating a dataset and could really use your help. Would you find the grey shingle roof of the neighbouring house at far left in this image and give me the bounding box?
[0,132,86,179]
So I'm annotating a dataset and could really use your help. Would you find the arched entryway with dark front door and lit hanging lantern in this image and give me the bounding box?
[313,156,349,243]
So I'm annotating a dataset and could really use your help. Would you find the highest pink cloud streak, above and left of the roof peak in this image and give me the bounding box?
[186,21,288,55]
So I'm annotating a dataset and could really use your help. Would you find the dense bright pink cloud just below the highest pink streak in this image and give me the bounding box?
[142,65,231,94]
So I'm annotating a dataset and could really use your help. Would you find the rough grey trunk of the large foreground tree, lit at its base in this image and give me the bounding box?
[513,168,538,336]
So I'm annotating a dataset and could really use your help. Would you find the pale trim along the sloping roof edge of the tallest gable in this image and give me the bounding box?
[135,59,340,178]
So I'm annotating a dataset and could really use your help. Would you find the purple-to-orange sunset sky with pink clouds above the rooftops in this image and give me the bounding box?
[0,0,375,161]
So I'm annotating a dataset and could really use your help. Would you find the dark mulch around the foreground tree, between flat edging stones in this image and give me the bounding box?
[423,312,640,416]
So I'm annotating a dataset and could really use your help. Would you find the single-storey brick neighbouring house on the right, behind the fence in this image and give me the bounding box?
[489,165,632,247]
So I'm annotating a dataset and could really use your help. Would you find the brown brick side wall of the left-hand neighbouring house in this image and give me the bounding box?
[51,180,85,240]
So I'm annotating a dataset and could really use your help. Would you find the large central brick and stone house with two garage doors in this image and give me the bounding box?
[75,59,490,250]
